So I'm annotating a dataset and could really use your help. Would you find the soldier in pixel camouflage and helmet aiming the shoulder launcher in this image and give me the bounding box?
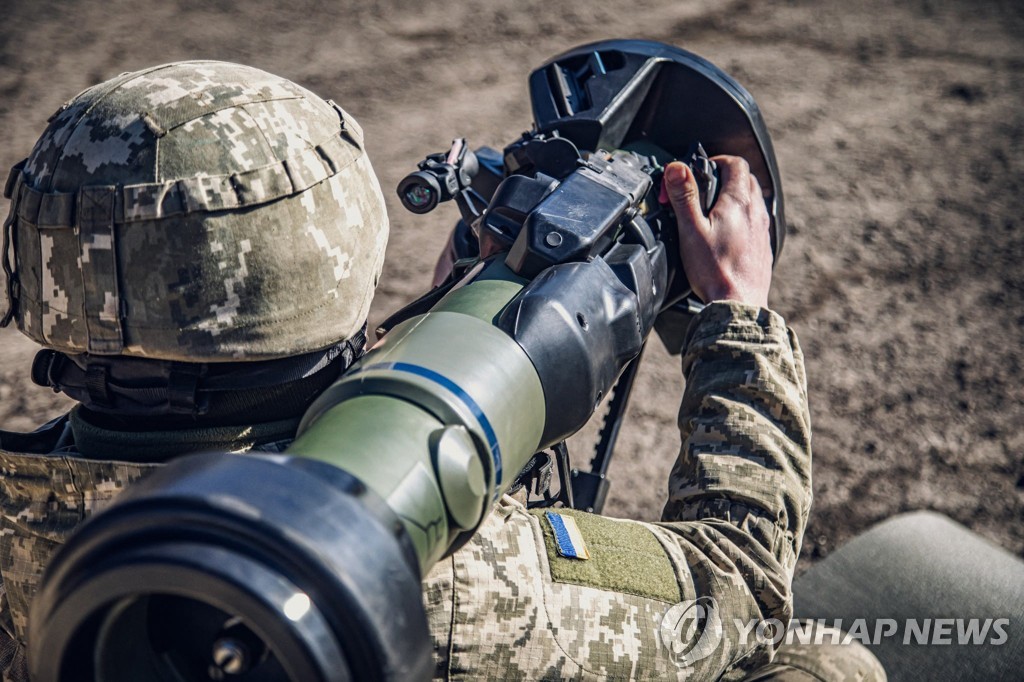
[0,61,884,680]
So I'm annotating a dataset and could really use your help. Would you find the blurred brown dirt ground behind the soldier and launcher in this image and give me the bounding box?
[0,0,1024,566]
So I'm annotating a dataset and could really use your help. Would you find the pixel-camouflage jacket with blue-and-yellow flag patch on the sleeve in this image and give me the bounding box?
[0,303,811,680]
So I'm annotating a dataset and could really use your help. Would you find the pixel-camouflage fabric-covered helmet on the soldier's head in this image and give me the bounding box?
[4,61,388,363]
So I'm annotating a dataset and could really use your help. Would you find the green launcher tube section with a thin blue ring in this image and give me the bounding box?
[288,261,545,574]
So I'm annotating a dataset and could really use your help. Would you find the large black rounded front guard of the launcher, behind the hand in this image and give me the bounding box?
[529,40,785,258]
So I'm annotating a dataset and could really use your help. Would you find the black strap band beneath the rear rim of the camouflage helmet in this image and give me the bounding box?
[32,325,366,417]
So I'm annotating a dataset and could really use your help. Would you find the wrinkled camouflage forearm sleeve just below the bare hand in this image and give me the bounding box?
[662,302,811,670]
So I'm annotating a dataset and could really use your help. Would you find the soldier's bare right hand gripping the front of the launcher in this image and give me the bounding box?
[665,157,772,307]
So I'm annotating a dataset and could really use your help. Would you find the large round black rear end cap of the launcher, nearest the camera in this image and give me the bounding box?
[29,455,431,682]
